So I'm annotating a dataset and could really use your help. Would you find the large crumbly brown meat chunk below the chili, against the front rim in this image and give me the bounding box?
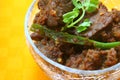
[66,49,118,70]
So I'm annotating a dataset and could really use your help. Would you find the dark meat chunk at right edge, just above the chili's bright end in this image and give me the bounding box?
[92,9,120,42]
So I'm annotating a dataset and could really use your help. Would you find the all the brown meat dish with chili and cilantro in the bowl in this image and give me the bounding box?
[30,0,120,70]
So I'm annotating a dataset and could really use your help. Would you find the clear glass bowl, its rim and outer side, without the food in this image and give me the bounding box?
[25,0,120,80]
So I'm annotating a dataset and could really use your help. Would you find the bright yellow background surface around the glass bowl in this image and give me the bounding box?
[0,0,120,80]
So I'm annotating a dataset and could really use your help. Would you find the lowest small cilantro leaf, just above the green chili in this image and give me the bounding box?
[76,19,91,33]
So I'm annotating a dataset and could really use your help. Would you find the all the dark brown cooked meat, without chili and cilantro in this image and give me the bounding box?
[31,0,120,70]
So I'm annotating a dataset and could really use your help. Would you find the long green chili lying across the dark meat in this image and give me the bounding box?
[31,24,120,49]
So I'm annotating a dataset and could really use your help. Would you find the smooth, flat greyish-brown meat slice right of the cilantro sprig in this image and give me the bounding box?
[83,4,113,37]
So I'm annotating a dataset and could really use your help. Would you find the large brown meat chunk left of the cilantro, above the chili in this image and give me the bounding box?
[34,0,73,29]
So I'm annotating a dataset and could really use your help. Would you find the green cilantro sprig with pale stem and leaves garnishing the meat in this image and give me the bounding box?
[62,0,99,33]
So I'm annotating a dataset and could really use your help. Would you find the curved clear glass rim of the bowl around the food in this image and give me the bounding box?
[25,0,120,75]
